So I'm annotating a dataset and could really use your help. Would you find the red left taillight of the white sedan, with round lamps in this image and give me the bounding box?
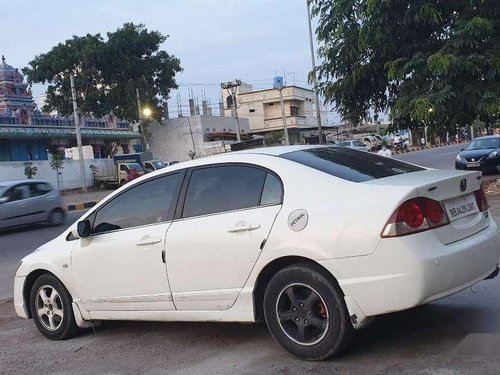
[380,198,450,238]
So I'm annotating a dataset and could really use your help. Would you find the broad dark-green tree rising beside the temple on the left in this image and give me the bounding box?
[23,23,182,121]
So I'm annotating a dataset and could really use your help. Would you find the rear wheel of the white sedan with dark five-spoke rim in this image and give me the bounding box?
[264,264,354,361]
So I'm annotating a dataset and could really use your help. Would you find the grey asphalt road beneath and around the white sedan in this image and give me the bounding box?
[0,145,500,375]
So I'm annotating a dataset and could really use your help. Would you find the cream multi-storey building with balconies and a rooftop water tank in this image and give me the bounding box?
[222,82,328,143]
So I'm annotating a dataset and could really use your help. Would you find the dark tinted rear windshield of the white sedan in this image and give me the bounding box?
[280,147,424,182]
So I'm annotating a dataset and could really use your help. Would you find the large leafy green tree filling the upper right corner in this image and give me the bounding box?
[312,0,500,134]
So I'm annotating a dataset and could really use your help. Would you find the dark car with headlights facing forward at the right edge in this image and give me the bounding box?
[455,135,500,172]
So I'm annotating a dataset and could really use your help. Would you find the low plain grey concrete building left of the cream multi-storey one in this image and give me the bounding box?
[148,115,250,162]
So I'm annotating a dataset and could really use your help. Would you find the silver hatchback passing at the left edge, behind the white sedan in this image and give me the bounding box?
[0,180,65,229]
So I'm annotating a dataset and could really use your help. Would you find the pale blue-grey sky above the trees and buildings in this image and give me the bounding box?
[0,0,339,122]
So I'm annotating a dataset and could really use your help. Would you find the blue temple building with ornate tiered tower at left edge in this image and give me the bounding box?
[0,56,140,161]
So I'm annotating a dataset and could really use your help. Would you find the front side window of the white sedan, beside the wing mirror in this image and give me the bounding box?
[92,173,181,234]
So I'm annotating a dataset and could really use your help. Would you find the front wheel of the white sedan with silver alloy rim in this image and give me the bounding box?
[30,273,79,340]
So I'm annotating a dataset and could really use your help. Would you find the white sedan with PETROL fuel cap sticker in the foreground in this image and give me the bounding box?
[14,146,500,360]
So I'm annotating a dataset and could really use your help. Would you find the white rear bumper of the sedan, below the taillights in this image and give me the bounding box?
[319,217,500,316]
